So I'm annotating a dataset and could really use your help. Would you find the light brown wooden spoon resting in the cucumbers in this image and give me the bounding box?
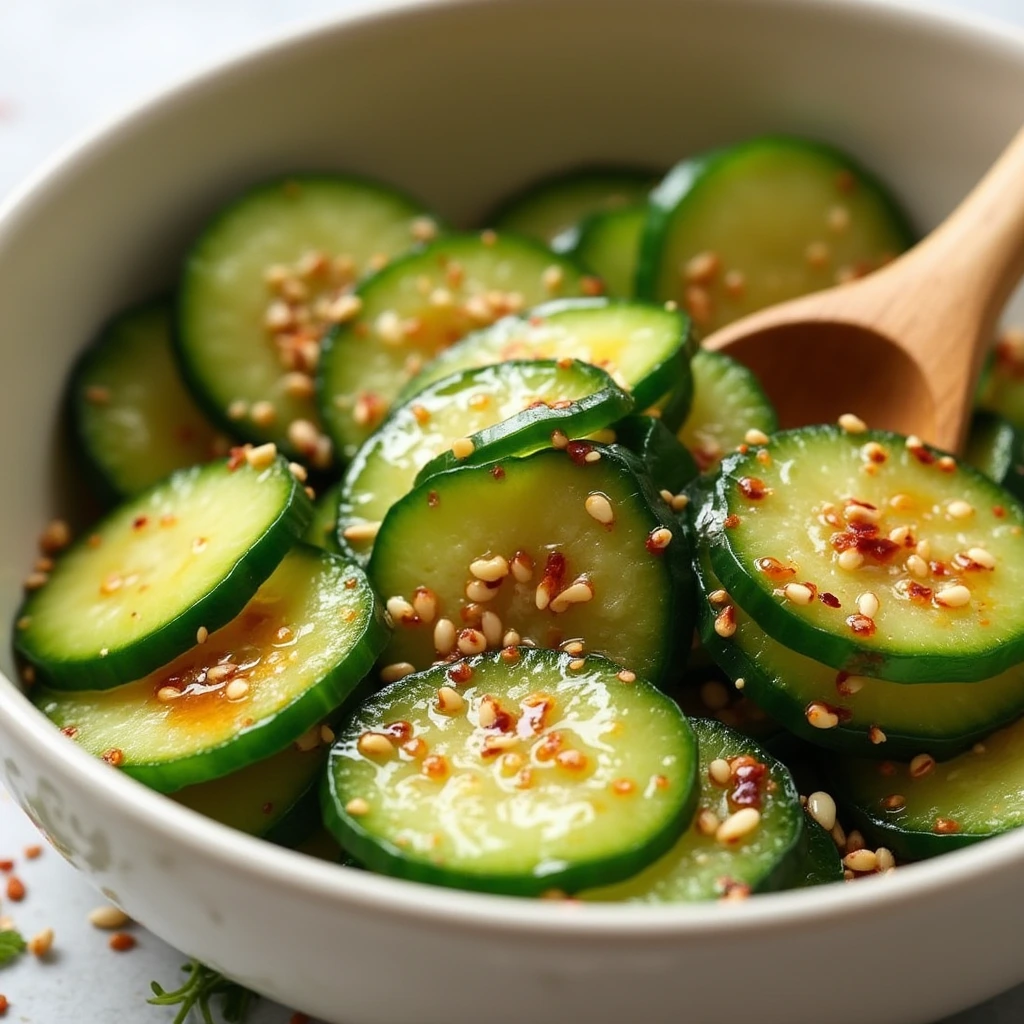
[705,129,1024,452]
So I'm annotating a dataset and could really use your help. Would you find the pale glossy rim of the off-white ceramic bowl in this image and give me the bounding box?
[6,0,1024,942]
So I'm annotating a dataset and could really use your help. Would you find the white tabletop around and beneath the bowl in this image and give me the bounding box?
[6,0,1024,1024]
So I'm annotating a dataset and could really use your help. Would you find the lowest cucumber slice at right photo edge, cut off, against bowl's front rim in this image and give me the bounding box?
[830,720,1024,860]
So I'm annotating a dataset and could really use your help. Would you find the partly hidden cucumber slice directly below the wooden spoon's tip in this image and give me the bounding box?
[679,350,778,473]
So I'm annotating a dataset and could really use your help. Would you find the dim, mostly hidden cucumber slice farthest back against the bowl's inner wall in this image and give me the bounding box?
[488,167,657,252]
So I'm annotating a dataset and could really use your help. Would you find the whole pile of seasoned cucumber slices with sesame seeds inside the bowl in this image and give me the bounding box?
[13,137,1024,903]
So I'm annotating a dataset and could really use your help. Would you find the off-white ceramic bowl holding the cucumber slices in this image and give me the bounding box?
[0,0,1024,1024]
